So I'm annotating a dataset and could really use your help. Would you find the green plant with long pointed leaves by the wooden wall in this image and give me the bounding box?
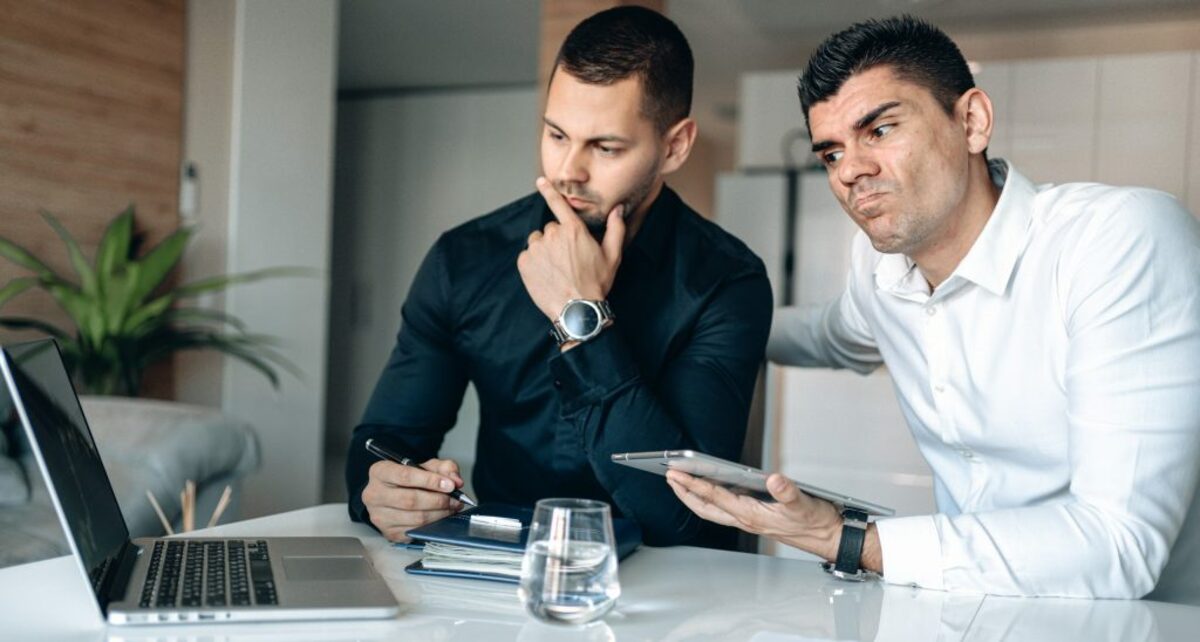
[0,205,307,396]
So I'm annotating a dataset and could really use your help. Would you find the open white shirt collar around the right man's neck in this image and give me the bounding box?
[875,158,1037,298]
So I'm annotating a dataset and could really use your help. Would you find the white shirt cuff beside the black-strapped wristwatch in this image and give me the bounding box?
[875,515,946,590]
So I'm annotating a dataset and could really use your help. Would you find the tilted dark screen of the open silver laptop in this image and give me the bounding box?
[0,341,130,590]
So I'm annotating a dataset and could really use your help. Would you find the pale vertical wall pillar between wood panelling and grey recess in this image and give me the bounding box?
[222,0,337,516]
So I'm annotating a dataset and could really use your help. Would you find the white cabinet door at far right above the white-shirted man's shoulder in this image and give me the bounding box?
[1094,52,1194,198]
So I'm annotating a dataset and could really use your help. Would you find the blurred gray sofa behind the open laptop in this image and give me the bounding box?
[0,396,259,566]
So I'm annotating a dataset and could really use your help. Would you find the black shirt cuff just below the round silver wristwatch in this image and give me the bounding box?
[550,325,638,413]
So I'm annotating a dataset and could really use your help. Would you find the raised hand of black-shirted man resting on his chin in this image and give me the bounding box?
[517,178,625,320]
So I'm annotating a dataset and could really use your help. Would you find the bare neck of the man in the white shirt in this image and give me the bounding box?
[910,158,1000,290]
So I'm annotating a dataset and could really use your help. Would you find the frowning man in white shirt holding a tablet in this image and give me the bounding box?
[667,17,1200,604]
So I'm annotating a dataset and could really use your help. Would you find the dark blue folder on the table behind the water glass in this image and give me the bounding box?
[404,504,642,584]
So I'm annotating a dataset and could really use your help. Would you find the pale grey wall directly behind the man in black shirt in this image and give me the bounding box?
[325,86,538,502]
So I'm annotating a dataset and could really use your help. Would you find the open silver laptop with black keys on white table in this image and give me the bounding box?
[0,340,400,625]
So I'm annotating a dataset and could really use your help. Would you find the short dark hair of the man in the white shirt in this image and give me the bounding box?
[798,14,974,128]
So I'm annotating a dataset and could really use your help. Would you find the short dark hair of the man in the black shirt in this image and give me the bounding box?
[551,6,695,133]
